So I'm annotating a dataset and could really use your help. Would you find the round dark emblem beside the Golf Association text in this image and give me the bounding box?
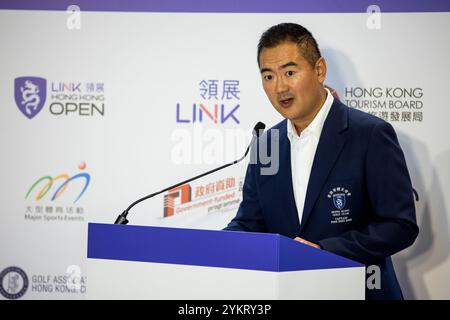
[0,267,28,299]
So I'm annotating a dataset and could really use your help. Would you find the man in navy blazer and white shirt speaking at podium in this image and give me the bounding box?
[225,23,419,299]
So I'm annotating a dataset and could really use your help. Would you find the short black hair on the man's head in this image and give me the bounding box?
[257,23,322,67]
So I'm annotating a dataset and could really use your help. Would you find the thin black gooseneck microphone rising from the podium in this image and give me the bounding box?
[114,122,266,224]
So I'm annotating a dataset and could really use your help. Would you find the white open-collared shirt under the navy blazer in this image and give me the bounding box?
[287,88,334,223]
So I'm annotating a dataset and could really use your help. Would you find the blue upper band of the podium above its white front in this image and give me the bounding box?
[87,223,363,272]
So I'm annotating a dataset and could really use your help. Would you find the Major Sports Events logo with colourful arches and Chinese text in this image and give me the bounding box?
[25,162,91,221]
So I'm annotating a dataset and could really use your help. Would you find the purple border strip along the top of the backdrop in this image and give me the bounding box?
[0,0,450,13]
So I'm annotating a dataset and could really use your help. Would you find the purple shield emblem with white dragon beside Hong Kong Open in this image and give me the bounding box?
[14,77,47,119]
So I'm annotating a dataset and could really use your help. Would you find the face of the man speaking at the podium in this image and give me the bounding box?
[259,41,326,123]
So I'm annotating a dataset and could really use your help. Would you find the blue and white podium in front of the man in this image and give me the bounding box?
[87,223,365,300]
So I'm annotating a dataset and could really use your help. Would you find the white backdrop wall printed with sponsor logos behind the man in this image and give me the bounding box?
[0,3,450,299]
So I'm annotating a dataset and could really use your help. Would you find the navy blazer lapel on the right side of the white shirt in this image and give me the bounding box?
[300,98,348,232]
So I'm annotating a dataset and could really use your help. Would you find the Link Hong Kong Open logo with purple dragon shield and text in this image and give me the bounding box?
[14,76,105,119]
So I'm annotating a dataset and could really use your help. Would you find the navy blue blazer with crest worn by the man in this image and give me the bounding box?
[224,99,419,299]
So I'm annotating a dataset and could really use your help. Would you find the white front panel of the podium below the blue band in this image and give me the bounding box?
[87,259,365,300]
